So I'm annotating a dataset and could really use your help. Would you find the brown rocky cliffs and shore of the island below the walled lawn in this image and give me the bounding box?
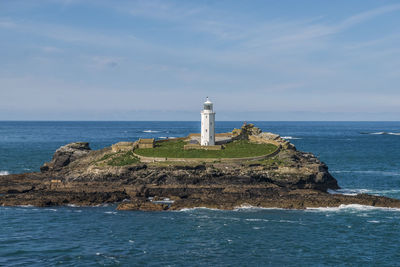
[0,125,400,210]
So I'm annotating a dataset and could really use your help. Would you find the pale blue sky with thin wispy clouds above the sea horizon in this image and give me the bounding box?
[0,0,400,121]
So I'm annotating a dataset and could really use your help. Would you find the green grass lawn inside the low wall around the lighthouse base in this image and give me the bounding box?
[135,140,277,158]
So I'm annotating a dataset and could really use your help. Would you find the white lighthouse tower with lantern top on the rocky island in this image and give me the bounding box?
[200,97,215,146]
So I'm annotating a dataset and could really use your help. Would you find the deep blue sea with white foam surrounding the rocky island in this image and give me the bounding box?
[0,121,400,266]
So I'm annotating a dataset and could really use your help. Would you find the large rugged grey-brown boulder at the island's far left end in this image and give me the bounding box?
[40,142,91,172]
